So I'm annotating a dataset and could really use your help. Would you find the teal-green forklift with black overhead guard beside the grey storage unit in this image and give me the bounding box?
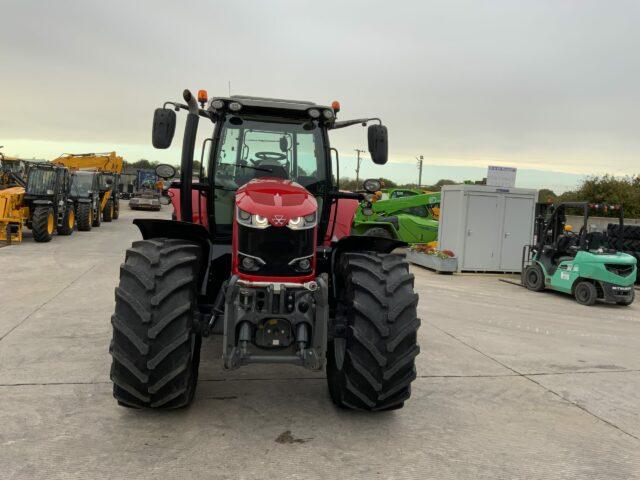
[522,202,637,306]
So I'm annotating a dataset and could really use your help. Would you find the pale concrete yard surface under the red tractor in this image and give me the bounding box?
[0,208,640,480]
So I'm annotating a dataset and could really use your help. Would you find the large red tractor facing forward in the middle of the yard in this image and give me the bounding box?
[110,90,420,411]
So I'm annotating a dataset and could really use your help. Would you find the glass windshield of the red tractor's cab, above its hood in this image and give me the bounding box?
[214,117,327,194]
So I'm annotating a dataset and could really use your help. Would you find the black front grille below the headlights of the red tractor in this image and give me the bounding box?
[238,225,316,277]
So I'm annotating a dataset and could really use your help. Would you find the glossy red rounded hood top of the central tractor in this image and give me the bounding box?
[236,178,318,227]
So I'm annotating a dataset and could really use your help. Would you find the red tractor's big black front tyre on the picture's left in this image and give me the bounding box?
[109,239,201,409]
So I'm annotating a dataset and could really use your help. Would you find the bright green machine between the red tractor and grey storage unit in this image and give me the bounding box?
[351,179,440,244]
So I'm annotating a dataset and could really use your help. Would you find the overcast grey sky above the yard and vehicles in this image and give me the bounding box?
[0,0,640,189]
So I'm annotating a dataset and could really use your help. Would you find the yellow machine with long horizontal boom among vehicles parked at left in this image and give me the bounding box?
[52,152,124,226]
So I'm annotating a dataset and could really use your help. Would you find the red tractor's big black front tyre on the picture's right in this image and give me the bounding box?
[327,252,420,411]
